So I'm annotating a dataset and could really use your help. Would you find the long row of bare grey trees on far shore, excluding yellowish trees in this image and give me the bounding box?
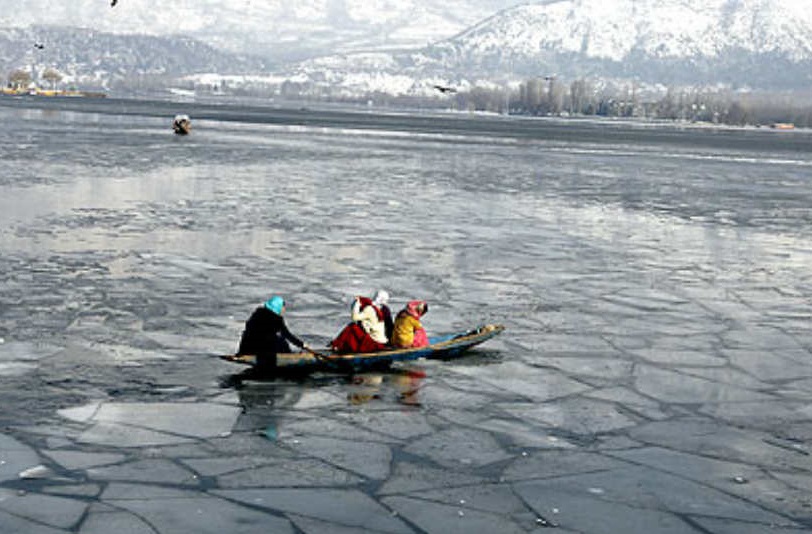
[154,79,812,130]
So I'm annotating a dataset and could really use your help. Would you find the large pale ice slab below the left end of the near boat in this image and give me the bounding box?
[58,402,240,447]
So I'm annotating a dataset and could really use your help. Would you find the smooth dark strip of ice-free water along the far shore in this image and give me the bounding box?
[0,93,812,152]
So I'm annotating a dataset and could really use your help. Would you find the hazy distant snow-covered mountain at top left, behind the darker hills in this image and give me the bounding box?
[0,0,522,61]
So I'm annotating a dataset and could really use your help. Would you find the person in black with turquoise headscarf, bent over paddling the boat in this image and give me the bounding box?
[237,296,311,369]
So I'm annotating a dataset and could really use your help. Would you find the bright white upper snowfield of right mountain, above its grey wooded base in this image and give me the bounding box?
[453,0,812,61]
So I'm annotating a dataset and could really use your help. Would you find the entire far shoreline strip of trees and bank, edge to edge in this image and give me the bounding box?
[0,84,812,131]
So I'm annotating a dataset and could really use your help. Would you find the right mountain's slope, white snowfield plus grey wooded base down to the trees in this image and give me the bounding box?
[427,0,812,86]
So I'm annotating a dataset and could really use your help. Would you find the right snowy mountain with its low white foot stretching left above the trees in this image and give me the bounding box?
[276,0,812,93]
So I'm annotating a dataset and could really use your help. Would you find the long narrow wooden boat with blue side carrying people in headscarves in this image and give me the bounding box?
[220,324,505,372]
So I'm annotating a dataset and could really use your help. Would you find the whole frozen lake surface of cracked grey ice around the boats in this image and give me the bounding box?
[0,98,812,534]
